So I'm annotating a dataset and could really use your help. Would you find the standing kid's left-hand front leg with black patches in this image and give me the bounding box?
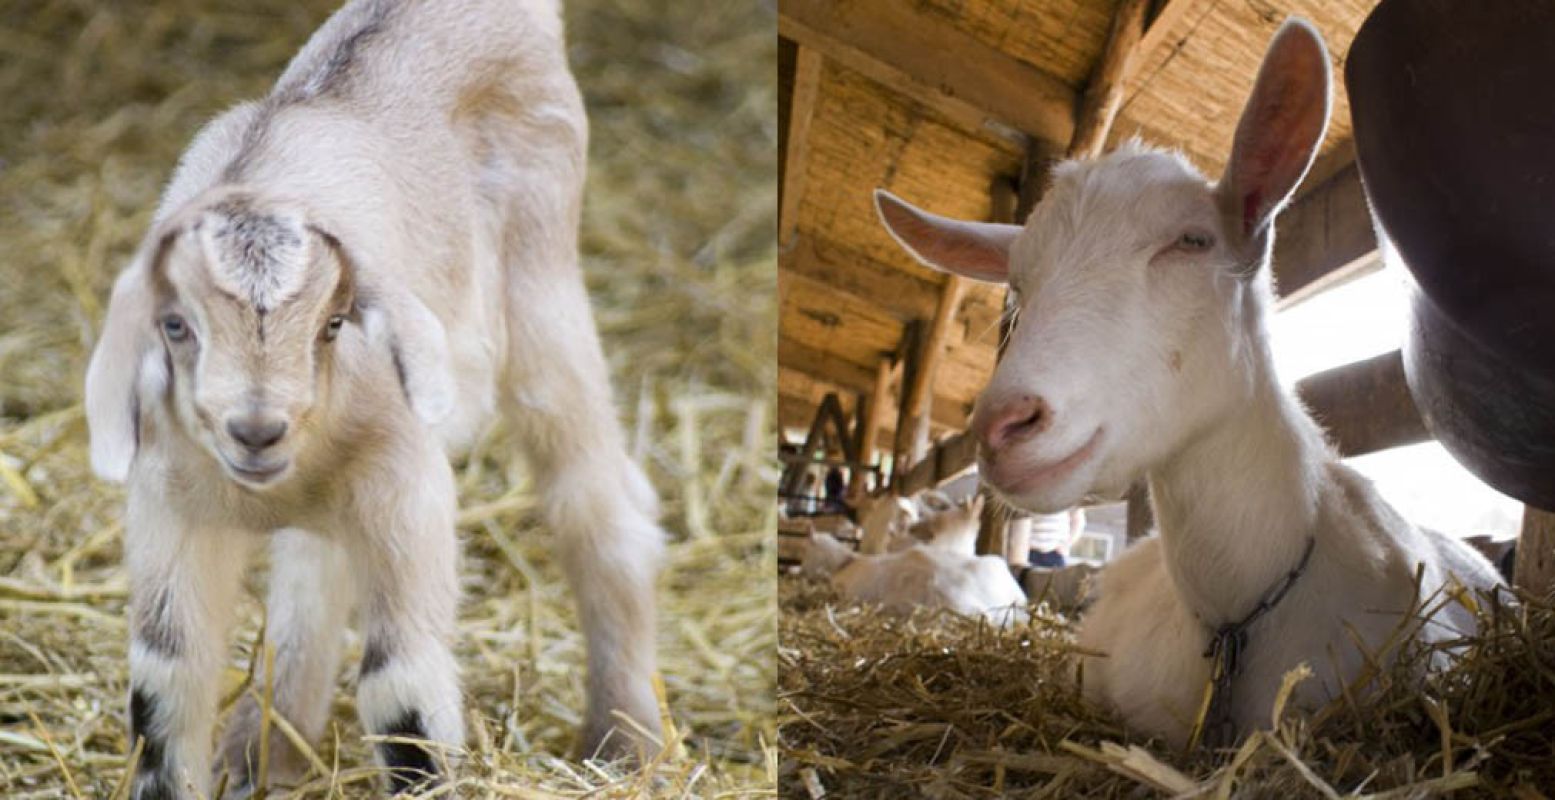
[124,492,252,800]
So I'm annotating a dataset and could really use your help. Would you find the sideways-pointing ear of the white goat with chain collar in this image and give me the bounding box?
[875,188,1020,283]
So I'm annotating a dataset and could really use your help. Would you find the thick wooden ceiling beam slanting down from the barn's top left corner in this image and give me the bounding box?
[778,0,1076,142]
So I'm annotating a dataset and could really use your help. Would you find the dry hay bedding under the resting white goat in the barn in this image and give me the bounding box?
[779,577,1555,800]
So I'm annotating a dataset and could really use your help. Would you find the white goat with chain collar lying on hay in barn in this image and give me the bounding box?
[879,20,1497,742]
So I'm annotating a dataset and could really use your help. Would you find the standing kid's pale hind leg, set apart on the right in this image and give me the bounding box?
[507,263,664,756]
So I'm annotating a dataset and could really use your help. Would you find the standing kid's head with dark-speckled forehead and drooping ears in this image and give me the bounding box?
[86,188,451,489]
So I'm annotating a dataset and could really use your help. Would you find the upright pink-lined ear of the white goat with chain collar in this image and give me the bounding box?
[1216,19,1331,240]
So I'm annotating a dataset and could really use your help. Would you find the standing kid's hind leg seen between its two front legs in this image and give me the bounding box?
[221,529,355,797]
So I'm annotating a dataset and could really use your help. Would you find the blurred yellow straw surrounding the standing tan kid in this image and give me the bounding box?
[0,0,776,798]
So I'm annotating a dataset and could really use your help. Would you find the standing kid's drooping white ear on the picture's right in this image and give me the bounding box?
[316,229,454,425]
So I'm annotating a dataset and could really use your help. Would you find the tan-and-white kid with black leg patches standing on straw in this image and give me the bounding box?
[86,0,662,798]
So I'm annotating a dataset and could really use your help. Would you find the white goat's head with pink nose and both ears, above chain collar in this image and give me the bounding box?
[875,20,1330,511]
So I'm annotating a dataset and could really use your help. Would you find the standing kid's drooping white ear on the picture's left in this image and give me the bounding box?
[84,232,177,482]
